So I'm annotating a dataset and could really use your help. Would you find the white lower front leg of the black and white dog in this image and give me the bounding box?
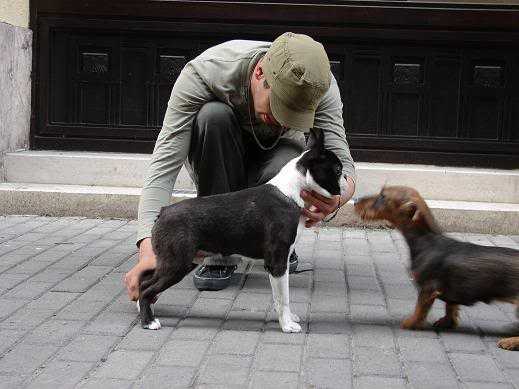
[269,250,301,332]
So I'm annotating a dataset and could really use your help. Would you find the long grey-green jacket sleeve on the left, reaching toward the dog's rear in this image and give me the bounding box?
[137,63,214,244]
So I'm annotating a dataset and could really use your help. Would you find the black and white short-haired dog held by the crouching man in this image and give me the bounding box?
[138,135,346,332]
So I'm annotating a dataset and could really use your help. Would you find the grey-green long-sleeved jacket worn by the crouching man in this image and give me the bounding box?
[137,40,355,241]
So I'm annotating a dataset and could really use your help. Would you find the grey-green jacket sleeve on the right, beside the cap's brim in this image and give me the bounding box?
[314,77,356,181]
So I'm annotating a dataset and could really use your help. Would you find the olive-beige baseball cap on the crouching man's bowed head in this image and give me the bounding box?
[262,32,331,129]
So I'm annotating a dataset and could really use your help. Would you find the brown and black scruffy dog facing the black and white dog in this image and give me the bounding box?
[355,186,519,350]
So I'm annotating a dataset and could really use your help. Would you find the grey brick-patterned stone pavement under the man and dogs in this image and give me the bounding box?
[0,216,519,389]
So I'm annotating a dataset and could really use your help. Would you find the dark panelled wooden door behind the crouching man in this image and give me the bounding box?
[31,0,519,168]
